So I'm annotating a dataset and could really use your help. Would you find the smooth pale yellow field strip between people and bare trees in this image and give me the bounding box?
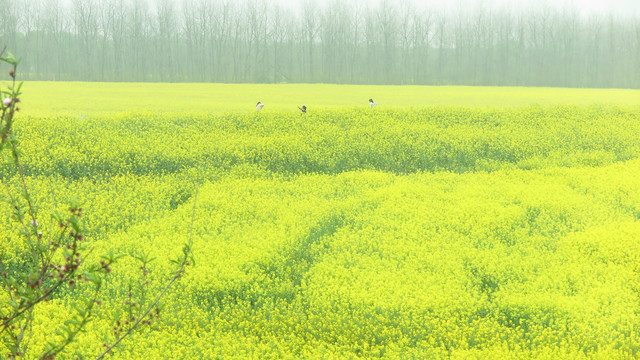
[21,81,640,118]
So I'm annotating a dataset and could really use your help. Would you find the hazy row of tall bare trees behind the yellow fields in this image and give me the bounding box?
[0,0,640,88]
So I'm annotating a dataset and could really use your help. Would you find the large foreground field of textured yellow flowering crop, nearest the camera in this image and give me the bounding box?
[0,89,640,359]
